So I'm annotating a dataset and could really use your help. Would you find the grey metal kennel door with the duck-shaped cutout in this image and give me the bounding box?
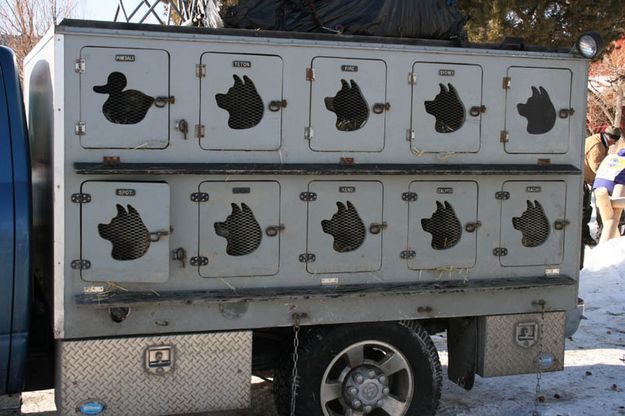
[74,47,175,149]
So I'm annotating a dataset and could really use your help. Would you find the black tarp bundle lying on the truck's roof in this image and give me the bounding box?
[224,0,466,40]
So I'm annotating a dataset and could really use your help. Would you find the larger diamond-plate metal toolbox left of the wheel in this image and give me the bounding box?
[57,331,252,416]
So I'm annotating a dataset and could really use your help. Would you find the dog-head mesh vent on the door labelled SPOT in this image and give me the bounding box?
[98,204,150,260]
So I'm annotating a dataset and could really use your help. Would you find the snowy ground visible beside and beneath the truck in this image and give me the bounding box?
[22,237,625,416]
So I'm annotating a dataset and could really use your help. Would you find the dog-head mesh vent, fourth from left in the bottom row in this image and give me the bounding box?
[421,201,462,250]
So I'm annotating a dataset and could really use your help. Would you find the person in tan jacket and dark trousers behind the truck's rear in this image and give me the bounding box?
[582,126,621,245]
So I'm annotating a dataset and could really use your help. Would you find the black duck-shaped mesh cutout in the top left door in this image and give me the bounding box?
[93,72,154,124]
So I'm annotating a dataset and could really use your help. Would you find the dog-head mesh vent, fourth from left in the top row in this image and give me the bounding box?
[425,84,466,133]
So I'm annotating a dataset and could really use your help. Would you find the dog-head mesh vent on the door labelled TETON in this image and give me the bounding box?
[215,75,265,130]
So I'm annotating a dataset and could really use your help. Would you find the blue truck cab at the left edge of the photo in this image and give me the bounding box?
[0,46,32,395]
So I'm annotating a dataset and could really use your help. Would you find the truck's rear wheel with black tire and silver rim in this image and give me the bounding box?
[274,321,442,416]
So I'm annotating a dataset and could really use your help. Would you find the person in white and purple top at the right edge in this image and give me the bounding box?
[592,148,625,242]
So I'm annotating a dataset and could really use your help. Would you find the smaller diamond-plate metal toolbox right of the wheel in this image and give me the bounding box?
[477,312,565,377]
